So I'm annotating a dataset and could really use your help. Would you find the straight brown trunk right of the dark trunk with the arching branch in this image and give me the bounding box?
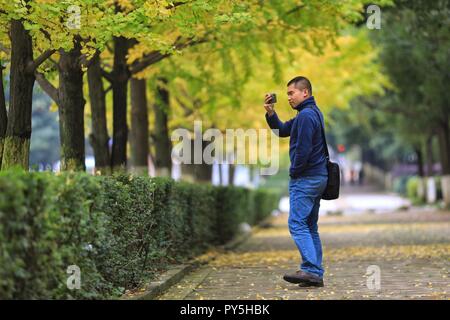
[130,78,149,174]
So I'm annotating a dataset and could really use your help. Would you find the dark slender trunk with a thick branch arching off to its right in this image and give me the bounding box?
[111,37,129,170]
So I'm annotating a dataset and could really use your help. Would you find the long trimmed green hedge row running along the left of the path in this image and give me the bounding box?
[0,171,279,299]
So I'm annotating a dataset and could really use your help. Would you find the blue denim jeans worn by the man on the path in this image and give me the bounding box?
[288,176,328,278]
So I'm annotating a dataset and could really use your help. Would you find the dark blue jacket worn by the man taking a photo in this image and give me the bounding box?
[266,96,328,179]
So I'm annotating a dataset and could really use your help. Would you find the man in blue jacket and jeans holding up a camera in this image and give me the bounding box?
[264,76,328,287]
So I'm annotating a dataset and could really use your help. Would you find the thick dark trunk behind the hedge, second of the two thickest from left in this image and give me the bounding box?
[58,42,85,171]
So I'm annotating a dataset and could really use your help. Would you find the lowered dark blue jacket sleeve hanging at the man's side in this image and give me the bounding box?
[289,114,314,178]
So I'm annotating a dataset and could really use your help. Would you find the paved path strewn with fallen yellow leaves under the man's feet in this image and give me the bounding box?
[159,209,450,300]
